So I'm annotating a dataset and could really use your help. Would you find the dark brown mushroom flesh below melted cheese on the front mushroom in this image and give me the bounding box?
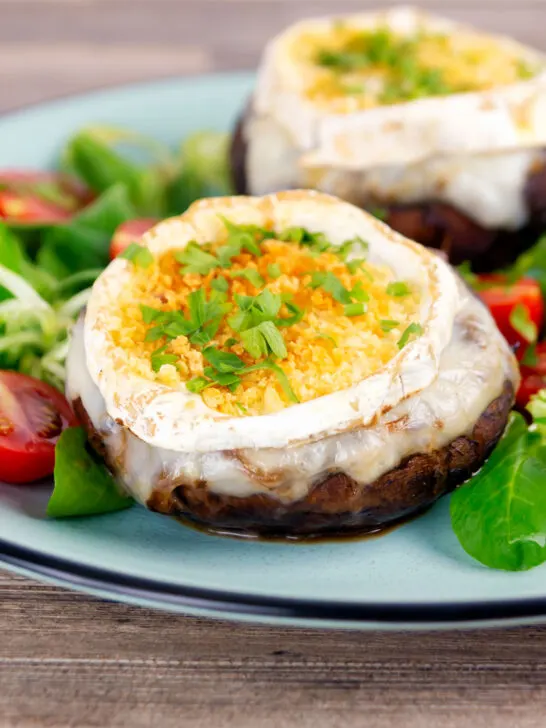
[74,381,514,537]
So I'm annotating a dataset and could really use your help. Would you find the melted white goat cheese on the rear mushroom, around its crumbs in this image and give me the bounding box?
[244,8,546,228]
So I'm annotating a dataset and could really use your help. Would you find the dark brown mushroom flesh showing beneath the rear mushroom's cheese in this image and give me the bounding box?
[230,112,546,271]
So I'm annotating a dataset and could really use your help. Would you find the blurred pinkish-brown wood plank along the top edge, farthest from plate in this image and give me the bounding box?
[0,0,546,49]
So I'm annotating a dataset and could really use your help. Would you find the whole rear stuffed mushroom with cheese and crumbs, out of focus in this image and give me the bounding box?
[231,8,546,269]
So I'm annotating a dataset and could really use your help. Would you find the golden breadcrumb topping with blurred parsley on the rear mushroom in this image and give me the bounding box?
[291,22,540,113]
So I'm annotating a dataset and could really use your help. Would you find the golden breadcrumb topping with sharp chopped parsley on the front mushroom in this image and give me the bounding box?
[109,221,421,416]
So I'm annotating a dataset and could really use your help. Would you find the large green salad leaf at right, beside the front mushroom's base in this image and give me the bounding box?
[451,406,546,571]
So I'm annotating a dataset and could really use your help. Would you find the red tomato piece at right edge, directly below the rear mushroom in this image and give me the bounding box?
[478,273,544,356]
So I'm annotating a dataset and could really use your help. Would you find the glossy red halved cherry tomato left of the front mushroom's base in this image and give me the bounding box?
[0,371,78,483]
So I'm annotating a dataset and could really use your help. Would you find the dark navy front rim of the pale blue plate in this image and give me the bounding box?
[0,539,546,627]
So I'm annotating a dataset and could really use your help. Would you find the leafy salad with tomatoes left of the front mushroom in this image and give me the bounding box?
[0,127,231,500]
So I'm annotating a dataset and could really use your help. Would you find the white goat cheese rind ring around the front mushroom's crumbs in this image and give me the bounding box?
[84,191,461,452]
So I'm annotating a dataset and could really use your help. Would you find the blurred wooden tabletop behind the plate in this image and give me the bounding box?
[0,0,546,111]
